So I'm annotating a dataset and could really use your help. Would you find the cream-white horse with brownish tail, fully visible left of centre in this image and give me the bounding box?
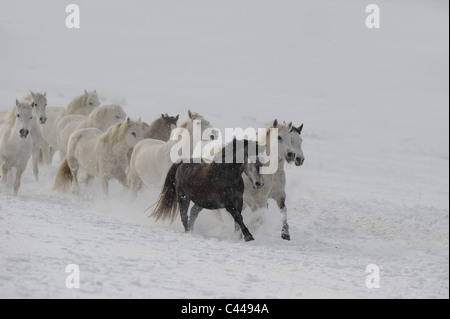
[53,118,144,197]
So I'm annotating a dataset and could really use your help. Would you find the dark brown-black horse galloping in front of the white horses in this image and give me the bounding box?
[150,139,264,241]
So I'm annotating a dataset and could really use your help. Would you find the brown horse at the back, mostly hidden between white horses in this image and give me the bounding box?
[128,113,180,162]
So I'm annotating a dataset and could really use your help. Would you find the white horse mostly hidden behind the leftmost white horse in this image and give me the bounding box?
[0,91,47,181]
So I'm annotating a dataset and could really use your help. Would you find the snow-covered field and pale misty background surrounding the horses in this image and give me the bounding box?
[0,0,449,298]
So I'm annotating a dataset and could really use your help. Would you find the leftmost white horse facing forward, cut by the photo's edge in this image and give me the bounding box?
[0,100,33,195]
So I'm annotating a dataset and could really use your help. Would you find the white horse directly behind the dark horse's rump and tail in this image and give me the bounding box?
[129,111,220,198]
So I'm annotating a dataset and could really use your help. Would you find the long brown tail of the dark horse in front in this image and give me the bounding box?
[150,162,182,223]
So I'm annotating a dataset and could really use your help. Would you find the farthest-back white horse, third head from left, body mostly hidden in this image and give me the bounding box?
[41,90,100,165]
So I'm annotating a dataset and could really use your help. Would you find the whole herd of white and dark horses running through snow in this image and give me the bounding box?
[0,90,304,241]
